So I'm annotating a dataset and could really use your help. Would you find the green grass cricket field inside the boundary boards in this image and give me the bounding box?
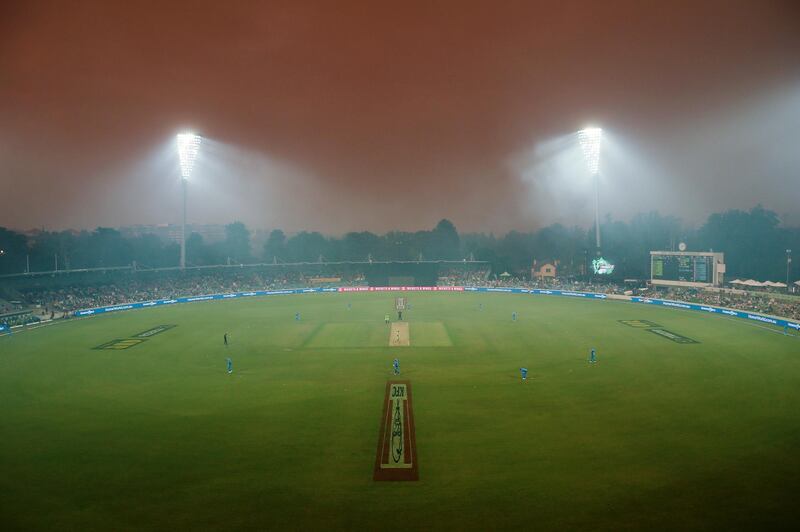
[0,293,800,531]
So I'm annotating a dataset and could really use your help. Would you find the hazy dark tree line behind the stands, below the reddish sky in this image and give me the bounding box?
[0,206,800,280]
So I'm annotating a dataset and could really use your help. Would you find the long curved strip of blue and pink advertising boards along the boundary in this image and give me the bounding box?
[67,286,800,331]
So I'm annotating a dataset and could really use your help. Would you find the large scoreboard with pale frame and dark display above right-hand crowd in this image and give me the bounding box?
[650,251,725,287]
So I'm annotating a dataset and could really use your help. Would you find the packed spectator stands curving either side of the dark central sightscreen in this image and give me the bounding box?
[6,268,800,325]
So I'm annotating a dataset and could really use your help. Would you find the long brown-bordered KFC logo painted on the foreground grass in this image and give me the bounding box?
[372,381,419,480]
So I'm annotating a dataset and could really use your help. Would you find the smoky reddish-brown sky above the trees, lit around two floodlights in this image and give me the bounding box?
[0,0,800,234]
